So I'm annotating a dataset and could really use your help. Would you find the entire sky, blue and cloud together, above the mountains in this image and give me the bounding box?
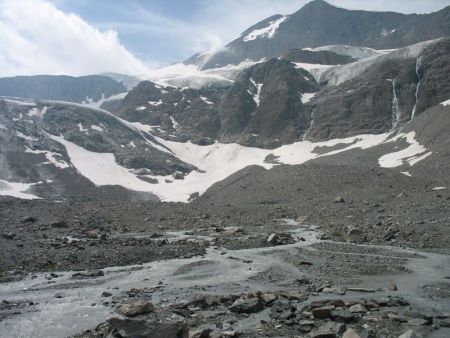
[0,0,450,76]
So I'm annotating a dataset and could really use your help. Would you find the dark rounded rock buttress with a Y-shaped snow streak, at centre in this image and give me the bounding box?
[219,59,317,147]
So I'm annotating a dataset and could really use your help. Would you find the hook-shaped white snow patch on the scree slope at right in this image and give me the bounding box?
[378,131,431,168]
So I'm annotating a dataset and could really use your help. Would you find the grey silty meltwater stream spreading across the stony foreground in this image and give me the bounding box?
[0,220,450,338]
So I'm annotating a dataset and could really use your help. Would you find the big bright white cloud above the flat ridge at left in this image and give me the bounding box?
[0,0,151,76]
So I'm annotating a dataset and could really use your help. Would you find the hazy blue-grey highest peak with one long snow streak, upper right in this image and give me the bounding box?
[186,0,450,69]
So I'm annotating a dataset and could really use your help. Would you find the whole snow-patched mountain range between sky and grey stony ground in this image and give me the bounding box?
[0,0,450,202]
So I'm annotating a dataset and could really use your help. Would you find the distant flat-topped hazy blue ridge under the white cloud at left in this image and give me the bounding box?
[0,75,127,103]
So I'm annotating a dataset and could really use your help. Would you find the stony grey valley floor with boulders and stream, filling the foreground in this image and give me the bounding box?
[0,189,450,337]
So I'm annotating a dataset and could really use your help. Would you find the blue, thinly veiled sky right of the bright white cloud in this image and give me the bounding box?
[50,0,450,64]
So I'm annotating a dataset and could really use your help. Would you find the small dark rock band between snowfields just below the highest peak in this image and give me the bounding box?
[283,49,357,65]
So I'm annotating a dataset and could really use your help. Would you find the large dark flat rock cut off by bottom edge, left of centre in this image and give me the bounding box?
[107,318,189,338]
